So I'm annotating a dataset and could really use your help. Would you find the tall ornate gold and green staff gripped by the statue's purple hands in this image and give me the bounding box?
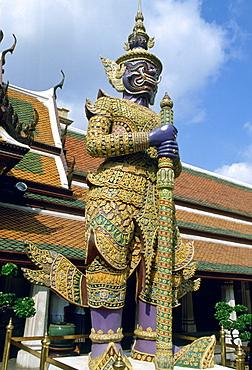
[155,93,174,370]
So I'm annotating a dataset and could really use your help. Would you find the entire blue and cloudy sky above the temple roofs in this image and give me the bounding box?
[0,0,252,184]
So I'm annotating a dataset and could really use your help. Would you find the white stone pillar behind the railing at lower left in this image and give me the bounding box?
[16,285,50,369]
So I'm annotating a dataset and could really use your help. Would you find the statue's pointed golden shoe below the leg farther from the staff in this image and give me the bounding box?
[88,342,133,370]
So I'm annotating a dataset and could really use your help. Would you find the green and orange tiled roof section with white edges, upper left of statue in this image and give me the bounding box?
[0,86,68,188]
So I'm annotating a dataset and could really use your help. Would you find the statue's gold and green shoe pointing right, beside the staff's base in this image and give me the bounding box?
[174,335,216,369]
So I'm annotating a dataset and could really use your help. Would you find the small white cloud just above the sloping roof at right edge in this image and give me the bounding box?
[214,162,252,184]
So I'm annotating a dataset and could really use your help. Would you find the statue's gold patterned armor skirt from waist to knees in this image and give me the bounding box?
[83,171,158,308]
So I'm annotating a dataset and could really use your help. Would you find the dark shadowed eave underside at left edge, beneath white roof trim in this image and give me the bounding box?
[0,141,30,176]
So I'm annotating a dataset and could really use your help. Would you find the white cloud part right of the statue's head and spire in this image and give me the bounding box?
[148,0,229,122]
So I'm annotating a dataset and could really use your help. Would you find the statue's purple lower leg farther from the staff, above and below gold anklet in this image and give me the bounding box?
[90,308,123,358]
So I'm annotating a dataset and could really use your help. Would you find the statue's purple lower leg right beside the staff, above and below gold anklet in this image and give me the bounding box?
[135,300,157,355]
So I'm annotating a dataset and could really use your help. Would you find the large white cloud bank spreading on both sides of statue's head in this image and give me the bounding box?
[0,0,248,132]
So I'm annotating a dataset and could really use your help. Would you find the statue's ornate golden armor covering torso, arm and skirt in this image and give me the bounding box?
[86,92,181,308]
